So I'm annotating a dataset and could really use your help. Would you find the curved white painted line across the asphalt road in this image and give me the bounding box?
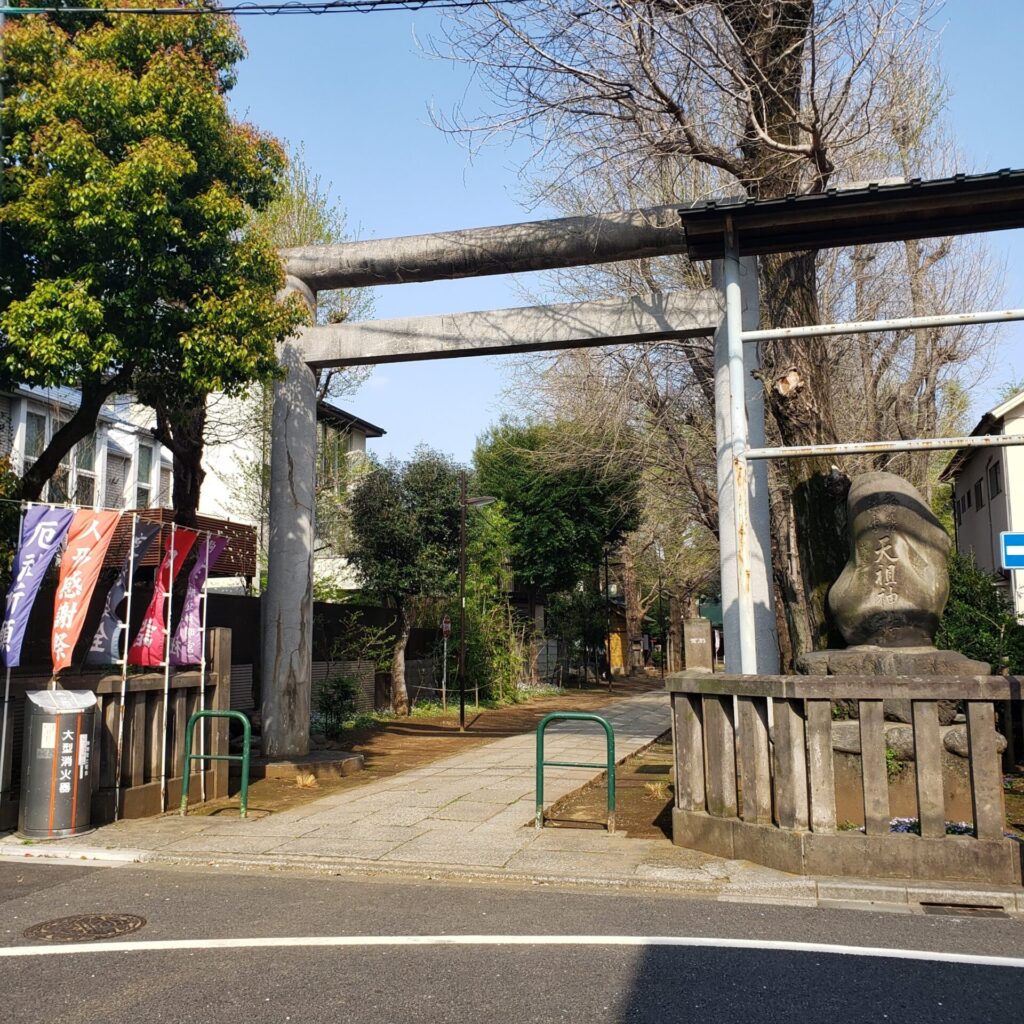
[0,935,1024,968]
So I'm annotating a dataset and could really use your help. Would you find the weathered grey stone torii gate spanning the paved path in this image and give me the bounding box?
[262,207,777,757]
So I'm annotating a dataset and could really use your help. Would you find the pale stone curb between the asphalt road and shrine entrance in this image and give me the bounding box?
[0,842,1024,914]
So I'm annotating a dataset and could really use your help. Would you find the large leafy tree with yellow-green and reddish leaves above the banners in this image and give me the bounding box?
[0,0,305,512]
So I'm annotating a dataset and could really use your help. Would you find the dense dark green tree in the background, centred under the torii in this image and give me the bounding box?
[474,423,640,594]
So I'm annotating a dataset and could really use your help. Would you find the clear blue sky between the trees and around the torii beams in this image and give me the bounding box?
[232,0,1024,460]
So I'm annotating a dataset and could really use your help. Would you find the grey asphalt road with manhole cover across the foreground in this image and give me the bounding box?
[0,862,1024,1024]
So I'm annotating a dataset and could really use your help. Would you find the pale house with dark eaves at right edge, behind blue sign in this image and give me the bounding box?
[940,391,1024,617]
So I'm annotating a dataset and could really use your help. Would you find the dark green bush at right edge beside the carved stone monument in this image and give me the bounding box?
[935,552,1024,675]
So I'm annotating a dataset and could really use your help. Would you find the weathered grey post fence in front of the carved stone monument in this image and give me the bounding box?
[667,673,1022,885]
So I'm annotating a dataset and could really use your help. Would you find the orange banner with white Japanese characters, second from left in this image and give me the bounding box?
[50,509,121,675]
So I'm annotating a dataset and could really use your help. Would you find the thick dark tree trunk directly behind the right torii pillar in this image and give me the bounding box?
[722,0,849,654]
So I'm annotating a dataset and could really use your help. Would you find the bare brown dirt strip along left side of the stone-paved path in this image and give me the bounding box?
[189,676,662,817]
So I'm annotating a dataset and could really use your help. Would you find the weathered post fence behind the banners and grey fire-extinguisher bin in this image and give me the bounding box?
[0,629,231,828]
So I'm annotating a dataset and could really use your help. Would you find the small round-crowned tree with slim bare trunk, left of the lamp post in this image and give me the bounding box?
[348,447,460,714]
